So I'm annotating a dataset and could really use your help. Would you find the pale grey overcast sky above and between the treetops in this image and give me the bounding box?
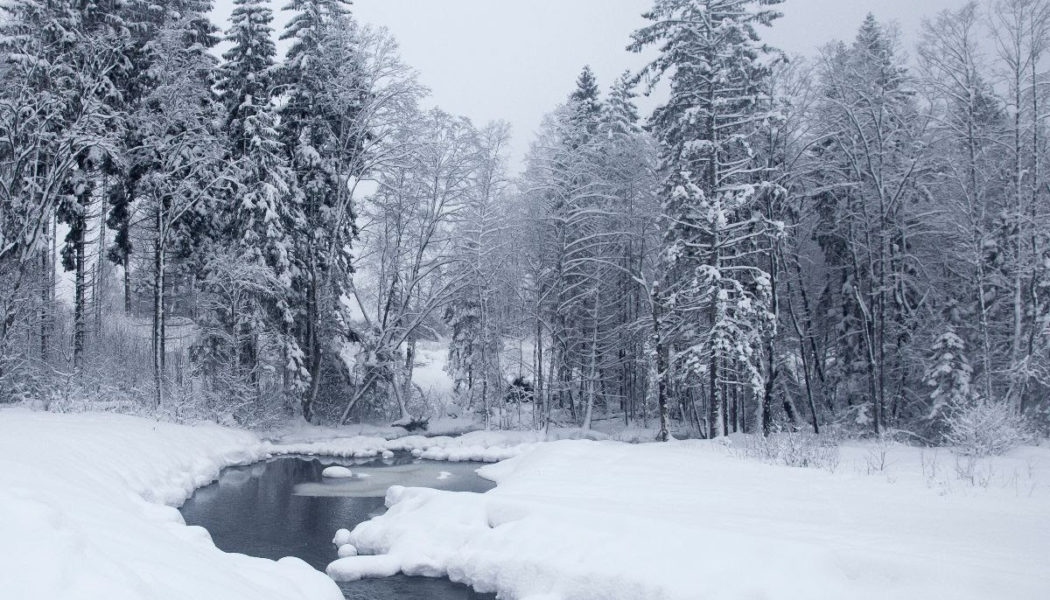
[214,0,966,169]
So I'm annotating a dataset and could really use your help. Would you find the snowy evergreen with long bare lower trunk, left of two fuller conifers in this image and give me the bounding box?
[130,3,232,406]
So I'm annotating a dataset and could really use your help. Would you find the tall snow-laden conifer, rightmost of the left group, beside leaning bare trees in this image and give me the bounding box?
[278,0,370,420]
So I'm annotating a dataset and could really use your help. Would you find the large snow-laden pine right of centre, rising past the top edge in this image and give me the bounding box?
[630,0,782,436]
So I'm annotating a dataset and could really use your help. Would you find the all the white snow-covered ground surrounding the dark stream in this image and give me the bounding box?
[0,409,1050,600]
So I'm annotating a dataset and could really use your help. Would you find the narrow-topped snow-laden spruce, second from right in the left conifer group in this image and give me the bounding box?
[200,0,302,414]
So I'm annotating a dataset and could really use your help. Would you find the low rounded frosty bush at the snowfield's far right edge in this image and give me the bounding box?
[944,398,1031,456]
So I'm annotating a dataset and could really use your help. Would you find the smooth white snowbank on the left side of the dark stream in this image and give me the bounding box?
[0,409,342,600]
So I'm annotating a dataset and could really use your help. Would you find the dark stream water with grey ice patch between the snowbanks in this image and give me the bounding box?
[180,455,495,600]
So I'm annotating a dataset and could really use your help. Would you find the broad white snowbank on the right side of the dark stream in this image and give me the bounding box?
[328,441,1050,600]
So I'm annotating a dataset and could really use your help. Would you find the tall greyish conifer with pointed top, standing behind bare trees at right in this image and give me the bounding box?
[812,15,929,434]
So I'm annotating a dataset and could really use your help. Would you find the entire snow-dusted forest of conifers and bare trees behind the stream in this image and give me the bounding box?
[0,0,1050,444]
